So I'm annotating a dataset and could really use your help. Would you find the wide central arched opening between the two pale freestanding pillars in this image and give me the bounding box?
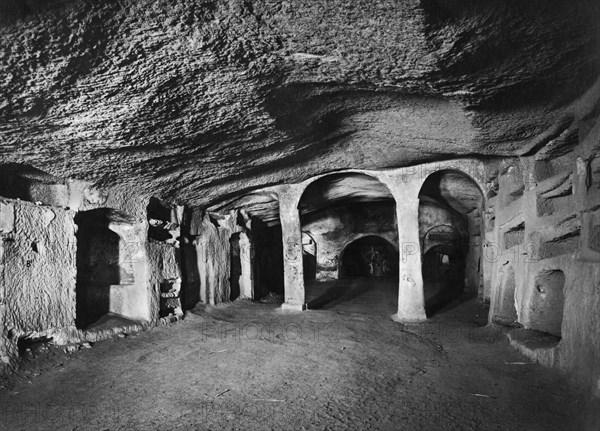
[298,172,399,313]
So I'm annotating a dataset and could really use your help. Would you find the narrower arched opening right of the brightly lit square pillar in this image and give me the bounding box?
[419,170,484,315]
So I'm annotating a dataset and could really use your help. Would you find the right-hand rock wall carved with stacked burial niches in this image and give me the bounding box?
[484,114,600,393]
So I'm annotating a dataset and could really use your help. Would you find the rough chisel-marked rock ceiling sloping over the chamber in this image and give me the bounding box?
[0,0,600,206]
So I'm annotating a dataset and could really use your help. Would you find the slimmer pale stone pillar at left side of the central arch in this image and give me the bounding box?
[278,185,306,310]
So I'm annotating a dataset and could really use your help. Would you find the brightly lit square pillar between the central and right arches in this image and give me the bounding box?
[392,196,427,322]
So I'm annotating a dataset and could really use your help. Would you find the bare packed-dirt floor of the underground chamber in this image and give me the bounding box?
[0,279,600,431]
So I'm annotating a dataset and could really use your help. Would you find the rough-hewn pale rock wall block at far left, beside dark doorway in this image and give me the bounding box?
[0,200,76,366]
